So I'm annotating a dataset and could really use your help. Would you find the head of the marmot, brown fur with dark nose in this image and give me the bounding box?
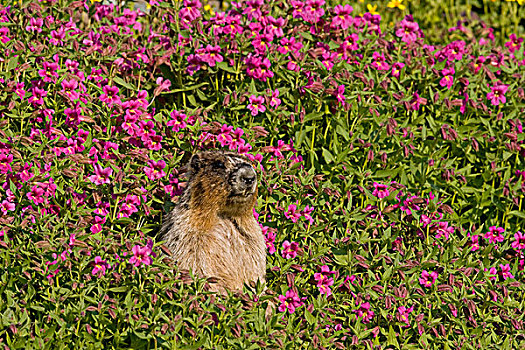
[188,151,257,216]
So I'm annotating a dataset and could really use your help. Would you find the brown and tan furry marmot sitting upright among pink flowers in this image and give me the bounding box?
[161,151,266,292]
